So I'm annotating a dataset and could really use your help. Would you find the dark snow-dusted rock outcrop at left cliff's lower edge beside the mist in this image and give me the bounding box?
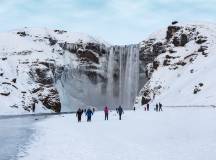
[27,60,64,112]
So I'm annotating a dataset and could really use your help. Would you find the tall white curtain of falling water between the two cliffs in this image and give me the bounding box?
[107,45,139,108]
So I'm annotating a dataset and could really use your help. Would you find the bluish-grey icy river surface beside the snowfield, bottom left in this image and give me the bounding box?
[0,116,44,160]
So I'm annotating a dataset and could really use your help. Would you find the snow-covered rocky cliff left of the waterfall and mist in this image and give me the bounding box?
[0,28,107,113]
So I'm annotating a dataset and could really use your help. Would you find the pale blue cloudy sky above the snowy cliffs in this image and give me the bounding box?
[0,0,216,44]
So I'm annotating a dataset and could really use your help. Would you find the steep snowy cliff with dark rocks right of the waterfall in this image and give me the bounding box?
[137,22,216,105]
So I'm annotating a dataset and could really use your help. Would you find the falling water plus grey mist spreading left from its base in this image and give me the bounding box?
[57,45,143,111]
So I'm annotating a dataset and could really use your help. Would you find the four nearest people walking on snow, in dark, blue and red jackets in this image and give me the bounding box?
[76,106,124,122]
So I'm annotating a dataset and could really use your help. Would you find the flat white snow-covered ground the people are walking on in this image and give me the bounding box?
[18,108,216,160]
